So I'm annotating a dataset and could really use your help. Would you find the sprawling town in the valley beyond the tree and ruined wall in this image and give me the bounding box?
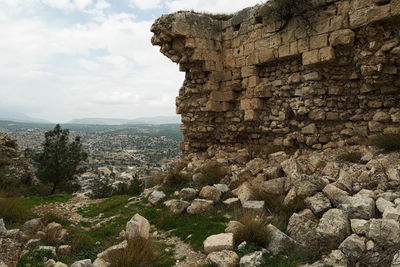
[0,121,182,194]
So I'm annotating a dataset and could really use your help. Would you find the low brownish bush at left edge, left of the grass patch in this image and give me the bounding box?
[0,198,32,224]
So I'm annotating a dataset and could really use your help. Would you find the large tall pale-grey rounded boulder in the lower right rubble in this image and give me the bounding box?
[316,209,350,251]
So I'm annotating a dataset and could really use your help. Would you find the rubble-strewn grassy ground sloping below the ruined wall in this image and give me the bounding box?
[0,141,400,267]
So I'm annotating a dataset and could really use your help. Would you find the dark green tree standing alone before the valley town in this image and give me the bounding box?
[34,124,87,194]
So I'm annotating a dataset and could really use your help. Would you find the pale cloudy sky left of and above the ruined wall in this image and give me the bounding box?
[0,0,261,122]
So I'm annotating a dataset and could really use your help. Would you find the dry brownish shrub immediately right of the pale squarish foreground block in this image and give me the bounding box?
[234,210,269,247]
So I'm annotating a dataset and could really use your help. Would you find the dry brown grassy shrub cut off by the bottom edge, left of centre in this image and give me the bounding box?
[111,235,167,267]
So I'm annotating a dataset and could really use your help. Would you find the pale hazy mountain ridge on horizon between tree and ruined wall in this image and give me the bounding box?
[68,116,181,125]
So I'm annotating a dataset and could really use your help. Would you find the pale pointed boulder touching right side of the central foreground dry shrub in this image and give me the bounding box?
[267,224,296,255]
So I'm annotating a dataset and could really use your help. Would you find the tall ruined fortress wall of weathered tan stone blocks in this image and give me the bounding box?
[151,0,400,153]
